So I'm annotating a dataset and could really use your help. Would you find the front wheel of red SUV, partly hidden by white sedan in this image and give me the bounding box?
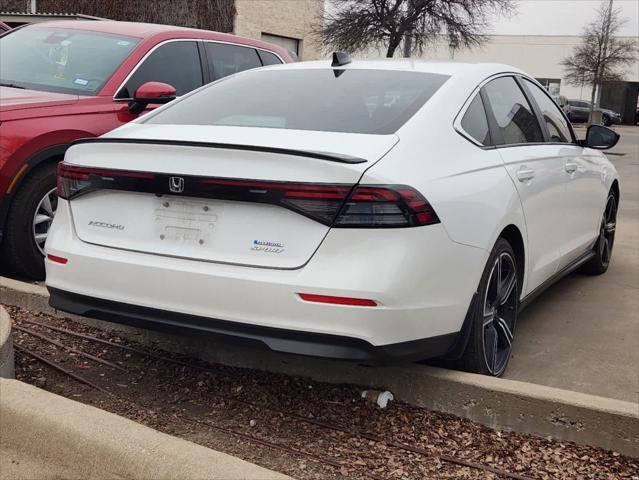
[2,163,56,280]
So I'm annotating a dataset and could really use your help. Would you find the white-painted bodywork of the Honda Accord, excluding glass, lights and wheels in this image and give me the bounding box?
[46,60,617,362]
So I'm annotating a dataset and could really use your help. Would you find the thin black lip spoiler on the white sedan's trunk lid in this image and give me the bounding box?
[71,137,367,164]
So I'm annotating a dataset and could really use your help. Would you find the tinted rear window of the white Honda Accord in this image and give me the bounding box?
[145,69,449,134]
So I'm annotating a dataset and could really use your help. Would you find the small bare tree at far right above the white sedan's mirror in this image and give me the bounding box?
[561,1,637,122]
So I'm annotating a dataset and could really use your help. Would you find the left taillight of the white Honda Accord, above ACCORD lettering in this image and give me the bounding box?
[57,162,155,200]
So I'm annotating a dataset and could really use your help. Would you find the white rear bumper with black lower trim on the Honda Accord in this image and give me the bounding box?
[45,200,488,360]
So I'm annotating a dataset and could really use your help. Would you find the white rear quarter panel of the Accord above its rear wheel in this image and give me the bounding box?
[362,79,526,291]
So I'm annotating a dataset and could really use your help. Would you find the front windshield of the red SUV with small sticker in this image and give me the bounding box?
[0,27,139,95]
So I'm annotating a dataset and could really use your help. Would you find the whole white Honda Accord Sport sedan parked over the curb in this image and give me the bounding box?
[46,55,619,376]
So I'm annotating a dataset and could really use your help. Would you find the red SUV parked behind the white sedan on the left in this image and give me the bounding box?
[0,21,294,279]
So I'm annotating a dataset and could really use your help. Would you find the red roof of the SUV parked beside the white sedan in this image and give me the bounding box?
[19,20,286,53]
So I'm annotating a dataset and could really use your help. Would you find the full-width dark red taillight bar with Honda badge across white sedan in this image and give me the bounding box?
[58,163,439,228]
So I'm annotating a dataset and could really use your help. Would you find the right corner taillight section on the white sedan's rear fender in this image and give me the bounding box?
[333,185,439,228]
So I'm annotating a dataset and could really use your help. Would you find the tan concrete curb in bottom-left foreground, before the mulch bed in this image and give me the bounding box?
[0,379,289,480]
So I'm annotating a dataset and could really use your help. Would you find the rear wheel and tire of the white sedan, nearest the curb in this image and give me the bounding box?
[459,238,520,377]
